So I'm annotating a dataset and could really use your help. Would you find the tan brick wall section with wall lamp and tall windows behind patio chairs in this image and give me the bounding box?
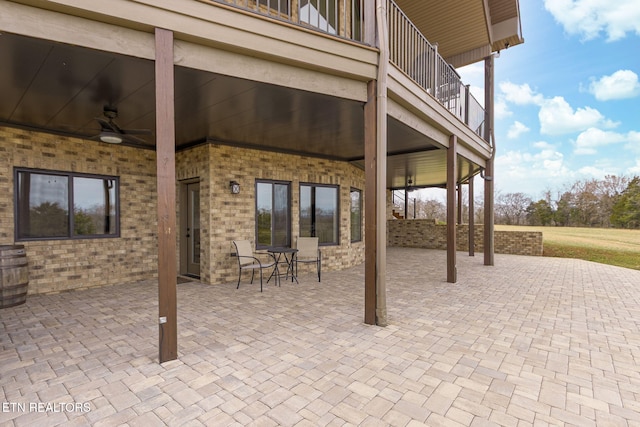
[177,144,364,283]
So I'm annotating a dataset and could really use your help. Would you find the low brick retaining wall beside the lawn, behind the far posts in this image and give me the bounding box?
[387,219,543,256]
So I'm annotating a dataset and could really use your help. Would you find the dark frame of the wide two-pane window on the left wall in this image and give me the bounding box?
[13,167,120,242]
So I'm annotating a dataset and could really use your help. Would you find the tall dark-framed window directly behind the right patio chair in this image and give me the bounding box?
[300,184,340,245]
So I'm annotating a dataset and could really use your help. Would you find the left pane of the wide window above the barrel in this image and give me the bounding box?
[17,172,69,238]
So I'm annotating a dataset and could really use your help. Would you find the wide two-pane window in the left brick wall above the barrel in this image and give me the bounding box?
[15,169,120,240]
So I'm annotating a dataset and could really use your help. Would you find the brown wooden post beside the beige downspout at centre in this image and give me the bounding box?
[364,80,378,325]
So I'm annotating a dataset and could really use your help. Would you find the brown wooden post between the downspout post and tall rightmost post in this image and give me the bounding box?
[447,135,458,283]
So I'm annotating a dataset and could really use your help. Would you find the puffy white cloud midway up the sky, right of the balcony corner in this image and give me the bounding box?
[538,96,617,135]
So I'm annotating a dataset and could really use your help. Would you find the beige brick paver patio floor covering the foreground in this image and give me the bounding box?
[0,248,640,426]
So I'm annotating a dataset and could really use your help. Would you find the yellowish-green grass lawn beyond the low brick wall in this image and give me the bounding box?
[495,225,640,270]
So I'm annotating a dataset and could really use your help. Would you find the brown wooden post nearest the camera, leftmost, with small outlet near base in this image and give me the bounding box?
[155,28,178,363]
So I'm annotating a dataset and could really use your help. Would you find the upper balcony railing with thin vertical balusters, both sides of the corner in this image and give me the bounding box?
[211,0,485,136]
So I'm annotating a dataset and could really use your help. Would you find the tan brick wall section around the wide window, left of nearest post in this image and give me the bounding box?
[0,127,157,293]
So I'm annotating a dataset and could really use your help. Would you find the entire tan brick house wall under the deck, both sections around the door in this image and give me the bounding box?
[0,127,364,293]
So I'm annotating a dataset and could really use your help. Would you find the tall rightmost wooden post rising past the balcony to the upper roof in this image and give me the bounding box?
[484,56,496,265]
